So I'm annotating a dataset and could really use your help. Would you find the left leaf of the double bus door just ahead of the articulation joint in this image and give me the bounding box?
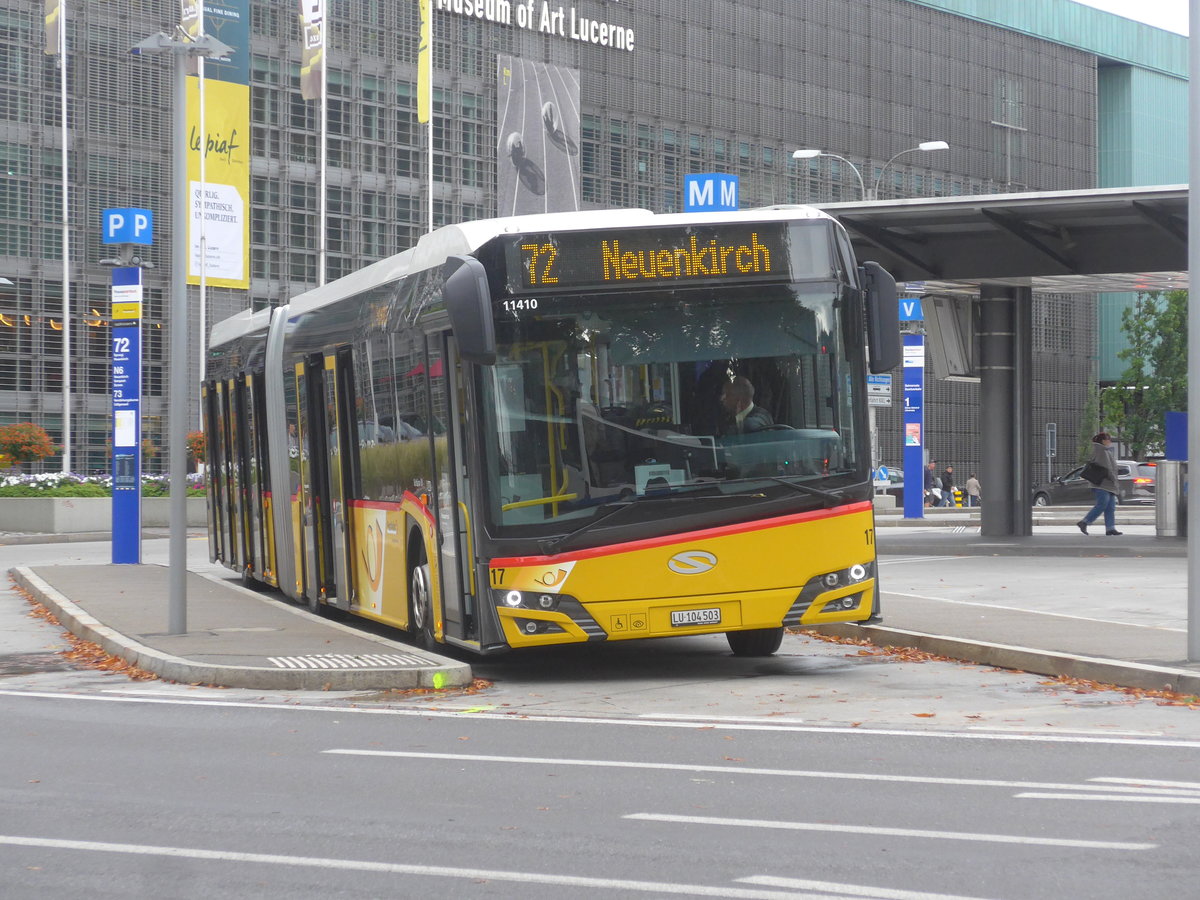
[295,354,335,610]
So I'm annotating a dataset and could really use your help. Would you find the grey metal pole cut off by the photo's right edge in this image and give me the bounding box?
[1188,0,1200,662]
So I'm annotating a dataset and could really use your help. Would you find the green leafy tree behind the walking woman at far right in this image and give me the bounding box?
[1102,290,1188,458]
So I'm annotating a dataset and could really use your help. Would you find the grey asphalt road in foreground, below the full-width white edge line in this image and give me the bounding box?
[0,692,1200,900]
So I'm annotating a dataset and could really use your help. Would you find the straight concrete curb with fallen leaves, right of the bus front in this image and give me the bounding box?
[806,623,1200,695]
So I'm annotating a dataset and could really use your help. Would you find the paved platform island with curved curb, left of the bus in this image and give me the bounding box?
[11,565,472,690]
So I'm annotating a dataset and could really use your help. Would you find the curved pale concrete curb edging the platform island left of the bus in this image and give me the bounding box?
[10,566,473,691]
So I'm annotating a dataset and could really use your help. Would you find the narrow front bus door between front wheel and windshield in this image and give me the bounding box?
[428,335,476,641]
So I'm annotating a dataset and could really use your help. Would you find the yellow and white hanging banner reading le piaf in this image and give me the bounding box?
[187,78,250,289]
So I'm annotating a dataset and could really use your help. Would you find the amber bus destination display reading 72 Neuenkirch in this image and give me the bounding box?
[506,223,790,294]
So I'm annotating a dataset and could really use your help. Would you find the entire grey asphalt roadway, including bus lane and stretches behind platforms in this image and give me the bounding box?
[0,540,1200,900]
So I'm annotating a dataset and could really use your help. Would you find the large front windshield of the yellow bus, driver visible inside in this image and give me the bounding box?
[480,281,865,536]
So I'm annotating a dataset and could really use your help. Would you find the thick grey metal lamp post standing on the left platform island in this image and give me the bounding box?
[167,46,190,635]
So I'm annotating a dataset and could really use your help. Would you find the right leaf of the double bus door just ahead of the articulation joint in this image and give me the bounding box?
[324,347,359,610]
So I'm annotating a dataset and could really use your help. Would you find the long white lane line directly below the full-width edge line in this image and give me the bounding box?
[320,748,1195,794]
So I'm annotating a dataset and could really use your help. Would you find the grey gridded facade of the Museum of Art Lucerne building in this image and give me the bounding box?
[0,0,1180,480]
